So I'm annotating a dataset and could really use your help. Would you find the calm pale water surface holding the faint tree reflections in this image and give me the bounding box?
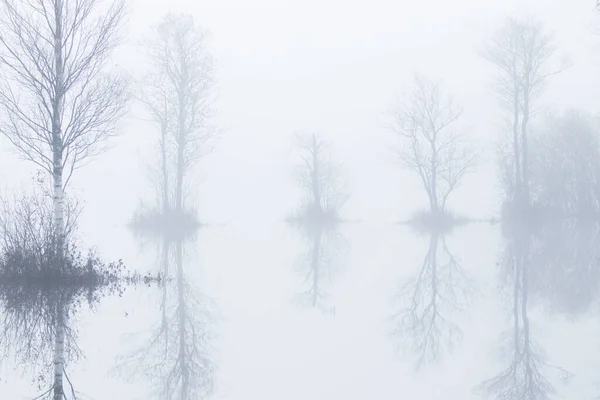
[0,223,600,400]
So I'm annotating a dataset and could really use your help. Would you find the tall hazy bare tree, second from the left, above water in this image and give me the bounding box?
[140,14,218,216]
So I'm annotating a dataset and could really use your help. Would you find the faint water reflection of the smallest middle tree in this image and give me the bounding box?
[295,221,345,314]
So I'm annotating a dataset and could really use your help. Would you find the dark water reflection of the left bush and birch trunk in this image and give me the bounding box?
[0,275,123,400]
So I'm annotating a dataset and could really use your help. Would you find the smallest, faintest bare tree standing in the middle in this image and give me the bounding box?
[296,133,348,218]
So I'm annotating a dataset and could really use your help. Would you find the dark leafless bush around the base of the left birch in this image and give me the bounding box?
[0,191,160,290]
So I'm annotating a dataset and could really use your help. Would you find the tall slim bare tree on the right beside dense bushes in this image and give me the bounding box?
[481,17,560,204]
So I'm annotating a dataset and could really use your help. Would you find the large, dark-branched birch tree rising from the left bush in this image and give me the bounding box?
[0,0,127,241]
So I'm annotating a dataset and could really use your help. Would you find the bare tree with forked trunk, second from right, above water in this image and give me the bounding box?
[391,75,475,213]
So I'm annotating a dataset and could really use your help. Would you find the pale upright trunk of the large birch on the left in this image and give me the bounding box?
[52,0,65,244]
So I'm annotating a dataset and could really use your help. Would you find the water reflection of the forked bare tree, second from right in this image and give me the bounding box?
[394,232,472,368]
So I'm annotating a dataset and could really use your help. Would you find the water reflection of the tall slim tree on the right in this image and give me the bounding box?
[479,234,570,400]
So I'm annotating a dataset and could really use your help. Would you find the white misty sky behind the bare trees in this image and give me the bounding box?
[0,0,600,244]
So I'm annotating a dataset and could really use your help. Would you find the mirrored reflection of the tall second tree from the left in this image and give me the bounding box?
[119,231,215,400]
